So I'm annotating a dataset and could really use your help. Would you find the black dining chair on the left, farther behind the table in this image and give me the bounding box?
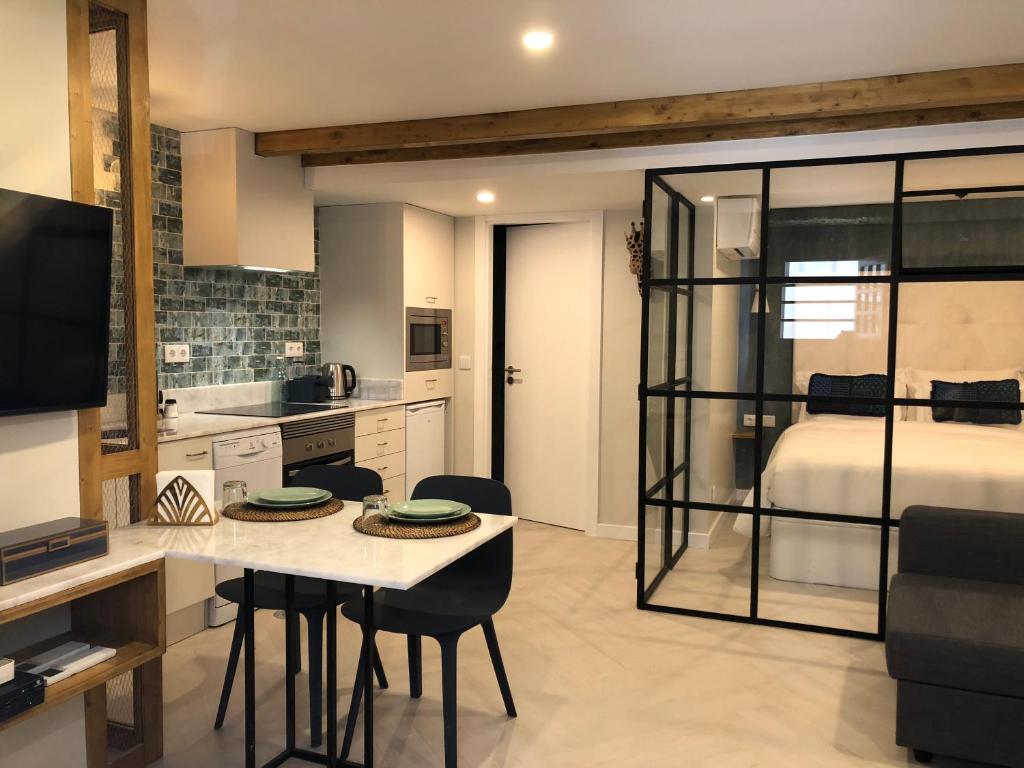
[213,465,388,746]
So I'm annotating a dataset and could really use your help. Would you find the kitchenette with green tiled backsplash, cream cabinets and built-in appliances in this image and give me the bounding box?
[146,126,455,642]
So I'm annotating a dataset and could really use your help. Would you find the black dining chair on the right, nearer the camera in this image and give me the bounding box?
[341,475,516,768]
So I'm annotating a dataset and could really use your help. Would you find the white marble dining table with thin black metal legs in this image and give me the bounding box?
[111,501,517,768]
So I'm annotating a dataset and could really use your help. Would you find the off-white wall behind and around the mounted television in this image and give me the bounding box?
[0,0,85,768]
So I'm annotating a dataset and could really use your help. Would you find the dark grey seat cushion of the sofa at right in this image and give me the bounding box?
[886,573,1024,697]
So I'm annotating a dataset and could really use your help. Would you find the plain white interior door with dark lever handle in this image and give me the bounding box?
[504,222,601,529]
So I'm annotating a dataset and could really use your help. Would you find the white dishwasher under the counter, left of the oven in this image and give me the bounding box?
[207,427,283,627]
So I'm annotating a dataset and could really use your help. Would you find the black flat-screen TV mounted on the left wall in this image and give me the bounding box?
[0,189,114,416]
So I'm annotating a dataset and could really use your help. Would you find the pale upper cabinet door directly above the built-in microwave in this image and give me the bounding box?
[402,206,455,309]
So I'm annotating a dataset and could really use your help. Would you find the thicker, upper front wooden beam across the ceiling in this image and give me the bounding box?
[256,63,1024,164]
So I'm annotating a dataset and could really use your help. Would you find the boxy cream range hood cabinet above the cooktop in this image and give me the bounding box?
[181,128,314,271]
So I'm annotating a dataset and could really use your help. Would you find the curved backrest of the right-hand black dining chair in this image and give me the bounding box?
[411,475,512,613]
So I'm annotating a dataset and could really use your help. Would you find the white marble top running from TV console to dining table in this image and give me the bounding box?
[0,502,518,610]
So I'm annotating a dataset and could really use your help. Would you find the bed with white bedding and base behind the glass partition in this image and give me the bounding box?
[736,415,1024,589]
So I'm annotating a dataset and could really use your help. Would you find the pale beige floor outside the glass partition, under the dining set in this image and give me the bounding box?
[160,522,978,768]
